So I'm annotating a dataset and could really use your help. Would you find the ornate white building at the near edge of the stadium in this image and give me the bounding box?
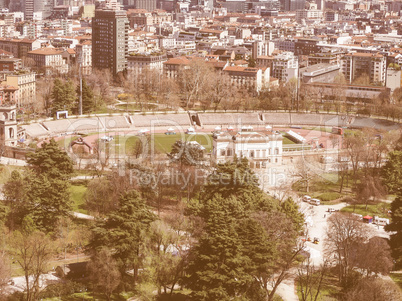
[212,127,283,169]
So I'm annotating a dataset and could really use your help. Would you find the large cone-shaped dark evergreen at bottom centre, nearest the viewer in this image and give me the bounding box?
[184,196,253,300]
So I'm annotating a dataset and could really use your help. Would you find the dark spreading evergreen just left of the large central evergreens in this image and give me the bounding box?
[89,190,155,284]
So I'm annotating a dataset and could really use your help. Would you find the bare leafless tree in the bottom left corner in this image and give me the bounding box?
[9,231,53,301]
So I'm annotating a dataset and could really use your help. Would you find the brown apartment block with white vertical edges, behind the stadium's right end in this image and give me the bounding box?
[341,53,386,84]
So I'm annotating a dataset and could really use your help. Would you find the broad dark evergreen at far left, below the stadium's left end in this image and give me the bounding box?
[3,139,73,232]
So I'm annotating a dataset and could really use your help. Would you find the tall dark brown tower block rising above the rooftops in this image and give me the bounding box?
[92,9,129,75]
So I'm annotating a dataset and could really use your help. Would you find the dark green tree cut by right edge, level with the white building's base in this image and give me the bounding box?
[381,150,402,193]
